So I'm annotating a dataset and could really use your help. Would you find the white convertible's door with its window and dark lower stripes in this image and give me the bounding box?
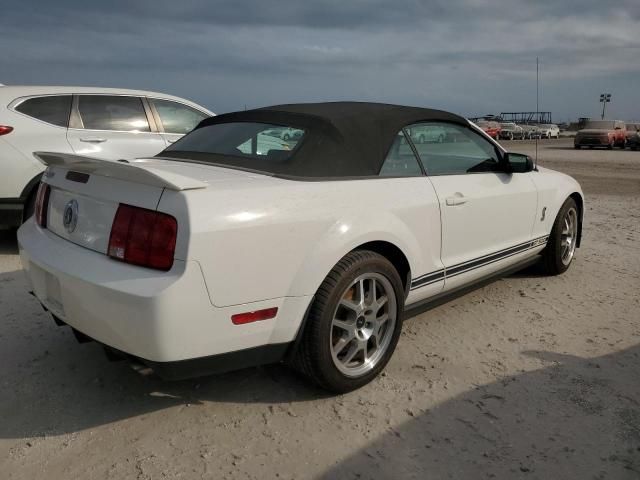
[408,122,538,290]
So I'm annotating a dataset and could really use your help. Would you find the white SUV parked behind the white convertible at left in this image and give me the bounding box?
[0,86,213,227]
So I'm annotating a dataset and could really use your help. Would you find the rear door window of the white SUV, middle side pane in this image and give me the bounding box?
[78,95,150,132]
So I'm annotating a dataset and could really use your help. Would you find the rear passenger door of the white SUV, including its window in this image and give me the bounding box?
[67,95,166,160]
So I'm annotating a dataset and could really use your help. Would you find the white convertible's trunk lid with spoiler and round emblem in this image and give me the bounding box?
[34,152,268,254]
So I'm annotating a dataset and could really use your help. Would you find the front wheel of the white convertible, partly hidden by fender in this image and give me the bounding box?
[542,197,580,275]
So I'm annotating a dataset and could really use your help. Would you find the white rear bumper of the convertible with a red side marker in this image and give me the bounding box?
[18,220,311,368]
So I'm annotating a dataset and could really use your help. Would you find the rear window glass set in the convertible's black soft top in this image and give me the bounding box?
[163,122,305,163]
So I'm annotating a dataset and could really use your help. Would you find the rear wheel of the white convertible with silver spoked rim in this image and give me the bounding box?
[293,250,404,393]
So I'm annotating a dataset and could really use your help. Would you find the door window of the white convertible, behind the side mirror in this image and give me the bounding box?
[408,122,501,175]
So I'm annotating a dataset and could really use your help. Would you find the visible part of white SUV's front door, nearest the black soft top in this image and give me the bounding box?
[148,98,209,146]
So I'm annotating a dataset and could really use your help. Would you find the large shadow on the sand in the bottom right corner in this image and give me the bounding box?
[325,346,640,480]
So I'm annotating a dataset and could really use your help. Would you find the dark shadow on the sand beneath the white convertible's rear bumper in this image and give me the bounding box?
[0,258,584,438]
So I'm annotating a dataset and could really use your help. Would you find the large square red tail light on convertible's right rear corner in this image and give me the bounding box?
[107,203,178,271]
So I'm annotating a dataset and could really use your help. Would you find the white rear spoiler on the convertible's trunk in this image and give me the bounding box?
[33,152,208,191]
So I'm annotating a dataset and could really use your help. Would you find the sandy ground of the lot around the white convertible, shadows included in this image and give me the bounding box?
[0,140,640,479]
